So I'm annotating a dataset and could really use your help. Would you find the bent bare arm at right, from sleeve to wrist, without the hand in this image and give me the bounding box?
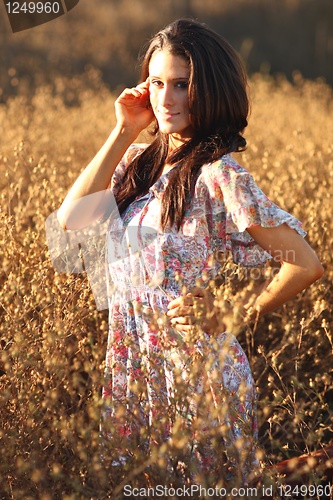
[244,224,324,319]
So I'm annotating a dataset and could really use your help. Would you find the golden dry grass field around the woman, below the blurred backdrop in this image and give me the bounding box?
[0,69,333,500]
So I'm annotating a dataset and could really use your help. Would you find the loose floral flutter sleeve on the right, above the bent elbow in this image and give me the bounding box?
[207,155,306,267]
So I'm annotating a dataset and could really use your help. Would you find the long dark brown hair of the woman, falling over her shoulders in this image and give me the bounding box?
[117,19,249,230]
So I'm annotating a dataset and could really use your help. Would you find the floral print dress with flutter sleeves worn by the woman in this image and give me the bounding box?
[102,144,305,481]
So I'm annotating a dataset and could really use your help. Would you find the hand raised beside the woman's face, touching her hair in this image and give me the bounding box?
[115,79,154,135]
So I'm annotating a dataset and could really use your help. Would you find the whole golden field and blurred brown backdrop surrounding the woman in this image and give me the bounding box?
[0,0,333,500]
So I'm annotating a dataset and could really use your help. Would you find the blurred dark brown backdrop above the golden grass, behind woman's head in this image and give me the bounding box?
[0,0,333,99]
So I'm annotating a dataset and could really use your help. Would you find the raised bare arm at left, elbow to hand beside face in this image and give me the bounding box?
[57,82,154,229]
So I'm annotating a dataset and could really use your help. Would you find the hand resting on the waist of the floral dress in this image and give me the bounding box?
[167,287,218,334]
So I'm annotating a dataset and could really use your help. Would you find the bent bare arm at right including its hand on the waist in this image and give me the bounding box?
[167,224,324,333]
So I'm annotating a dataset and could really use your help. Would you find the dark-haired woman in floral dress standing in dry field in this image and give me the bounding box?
[58,20,323,482]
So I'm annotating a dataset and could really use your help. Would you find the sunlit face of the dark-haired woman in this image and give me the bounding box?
[149,50,192,147]
